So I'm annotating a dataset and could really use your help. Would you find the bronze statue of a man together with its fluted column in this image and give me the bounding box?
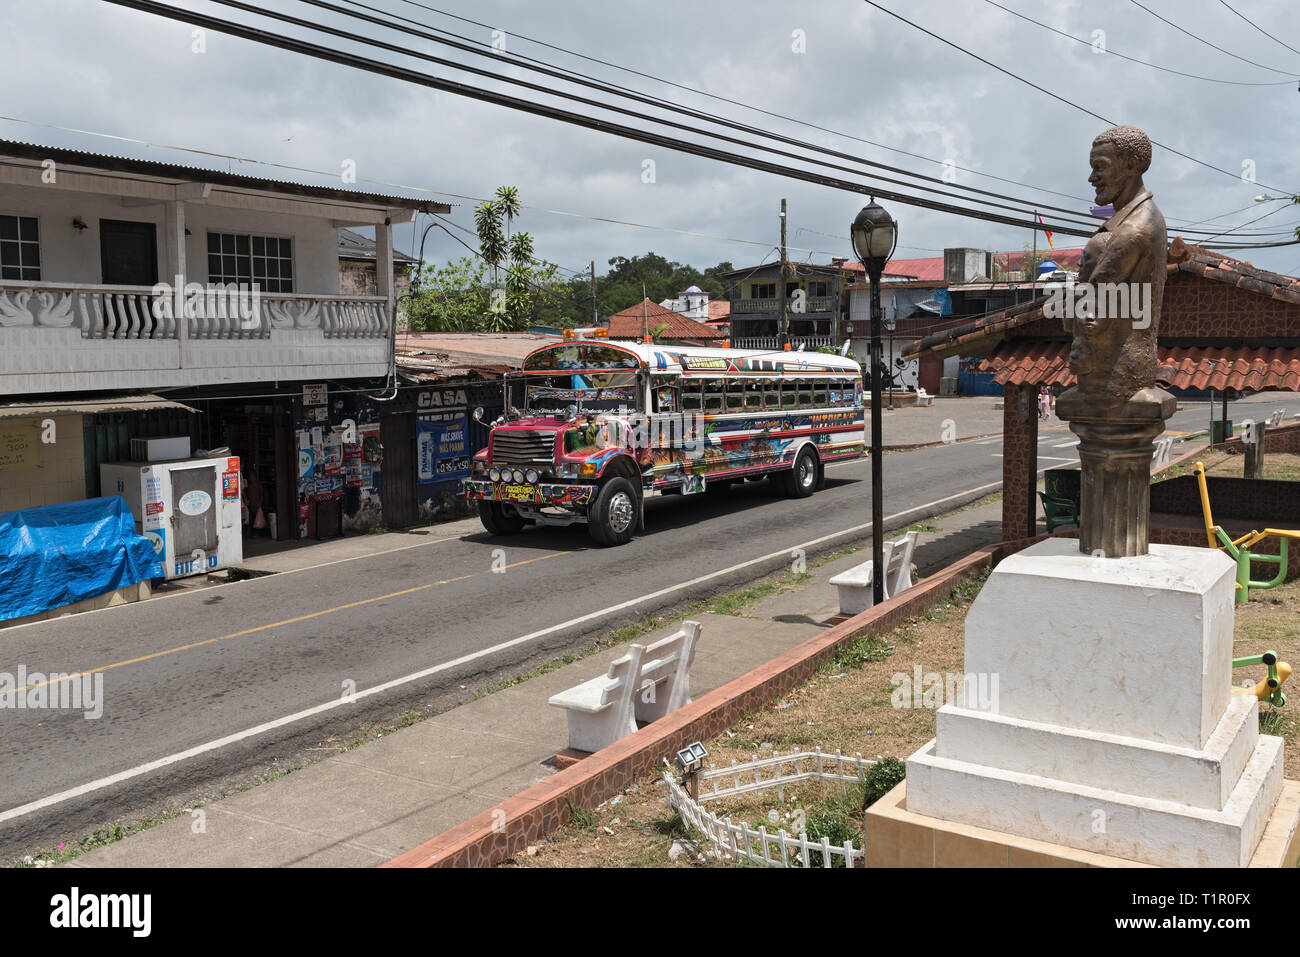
[1057,126,1177,558]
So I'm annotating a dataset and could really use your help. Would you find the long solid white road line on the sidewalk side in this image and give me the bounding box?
[0,481,998,823]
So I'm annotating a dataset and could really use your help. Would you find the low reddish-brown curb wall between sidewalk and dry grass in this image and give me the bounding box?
[381,536,1045,867]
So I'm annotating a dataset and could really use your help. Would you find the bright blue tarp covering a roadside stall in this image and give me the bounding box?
[0,495,164,620]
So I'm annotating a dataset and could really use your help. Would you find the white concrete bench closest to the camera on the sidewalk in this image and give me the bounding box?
[550,622,701,752]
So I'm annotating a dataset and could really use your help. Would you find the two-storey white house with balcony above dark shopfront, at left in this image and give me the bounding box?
[0,140,450,538]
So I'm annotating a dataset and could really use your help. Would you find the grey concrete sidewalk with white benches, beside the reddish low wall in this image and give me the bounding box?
[68,502,1001,867]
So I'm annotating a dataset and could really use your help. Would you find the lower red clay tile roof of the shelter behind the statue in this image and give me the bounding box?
[978,342,1300,391]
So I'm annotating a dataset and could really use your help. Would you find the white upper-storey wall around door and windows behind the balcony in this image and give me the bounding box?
[0,185,338,295]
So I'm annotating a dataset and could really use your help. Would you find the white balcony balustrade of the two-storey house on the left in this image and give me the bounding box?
[0,281,390,394]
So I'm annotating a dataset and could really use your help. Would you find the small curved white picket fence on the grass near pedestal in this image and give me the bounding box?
[663,748,876,867]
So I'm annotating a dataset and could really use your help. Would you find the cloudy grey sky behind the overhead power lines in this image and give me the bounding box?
[0,0,1300,274]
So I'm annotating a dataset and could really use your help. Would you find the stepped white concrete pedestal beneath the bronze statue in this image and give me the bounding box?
[907,538,1282,867]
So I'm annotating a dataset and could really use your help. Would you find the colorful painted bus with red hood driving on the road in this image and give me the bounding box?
[465,329,865,545]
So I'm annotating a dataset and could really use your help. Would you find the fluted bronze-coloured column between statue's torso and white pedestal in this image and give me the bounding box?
[1057,389,1178,558]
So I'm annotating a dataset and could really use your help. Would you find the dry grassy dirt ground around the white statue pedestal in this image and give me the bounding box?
[502,564,1300,867]
